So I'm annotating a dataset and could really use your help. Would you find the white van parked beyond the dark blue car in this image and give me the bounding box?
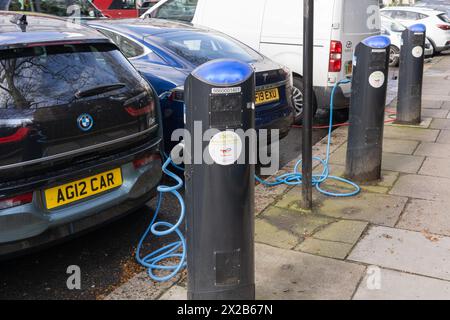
[142,0,380,119]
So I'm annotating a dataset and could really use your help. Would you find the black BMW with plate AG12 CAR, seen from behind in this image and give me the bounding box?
[0,11,162,257]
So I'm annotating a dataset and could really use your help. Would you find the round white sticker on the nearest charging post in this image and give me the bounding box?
[208,131,242,166]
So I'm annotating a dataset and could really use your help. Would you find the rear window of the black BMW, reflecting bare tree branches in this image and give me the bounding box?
[0,44,142,110]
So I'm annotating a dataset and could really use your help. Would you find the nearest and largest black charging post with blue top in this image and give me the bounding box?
[185,60,255,300]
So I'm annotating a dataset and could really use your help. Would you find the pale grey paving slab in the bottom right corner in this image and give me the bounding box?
[353,269,450,300]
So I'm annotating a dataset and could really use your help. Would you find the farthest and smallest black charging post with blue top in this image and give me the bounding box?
[396,24,426,124]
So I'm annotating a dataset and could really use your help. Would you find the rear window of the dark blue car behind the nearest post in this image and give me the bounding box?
[148,31,262,66]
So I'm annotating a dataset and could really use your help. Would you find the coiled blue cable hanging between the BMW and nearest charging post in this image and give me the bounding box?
[136,158,186,282]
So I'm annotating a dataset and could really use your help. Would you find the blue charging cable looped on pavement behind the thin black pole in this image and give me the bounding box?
[255,79,361,197]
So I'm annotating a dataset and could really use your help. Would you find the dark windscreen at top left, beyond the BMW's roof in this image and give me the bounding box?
[6,0,103,18]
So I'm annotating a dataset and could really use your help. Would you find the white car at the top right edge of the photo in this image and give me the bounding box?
[381,7,450,52]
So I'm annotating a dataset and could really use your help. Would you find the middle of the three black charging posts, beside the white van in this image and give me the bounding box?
[346,36,391,181]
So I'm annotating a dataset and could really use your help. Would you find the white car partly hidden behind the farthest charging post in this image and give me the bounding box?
[381,15,434,67]
